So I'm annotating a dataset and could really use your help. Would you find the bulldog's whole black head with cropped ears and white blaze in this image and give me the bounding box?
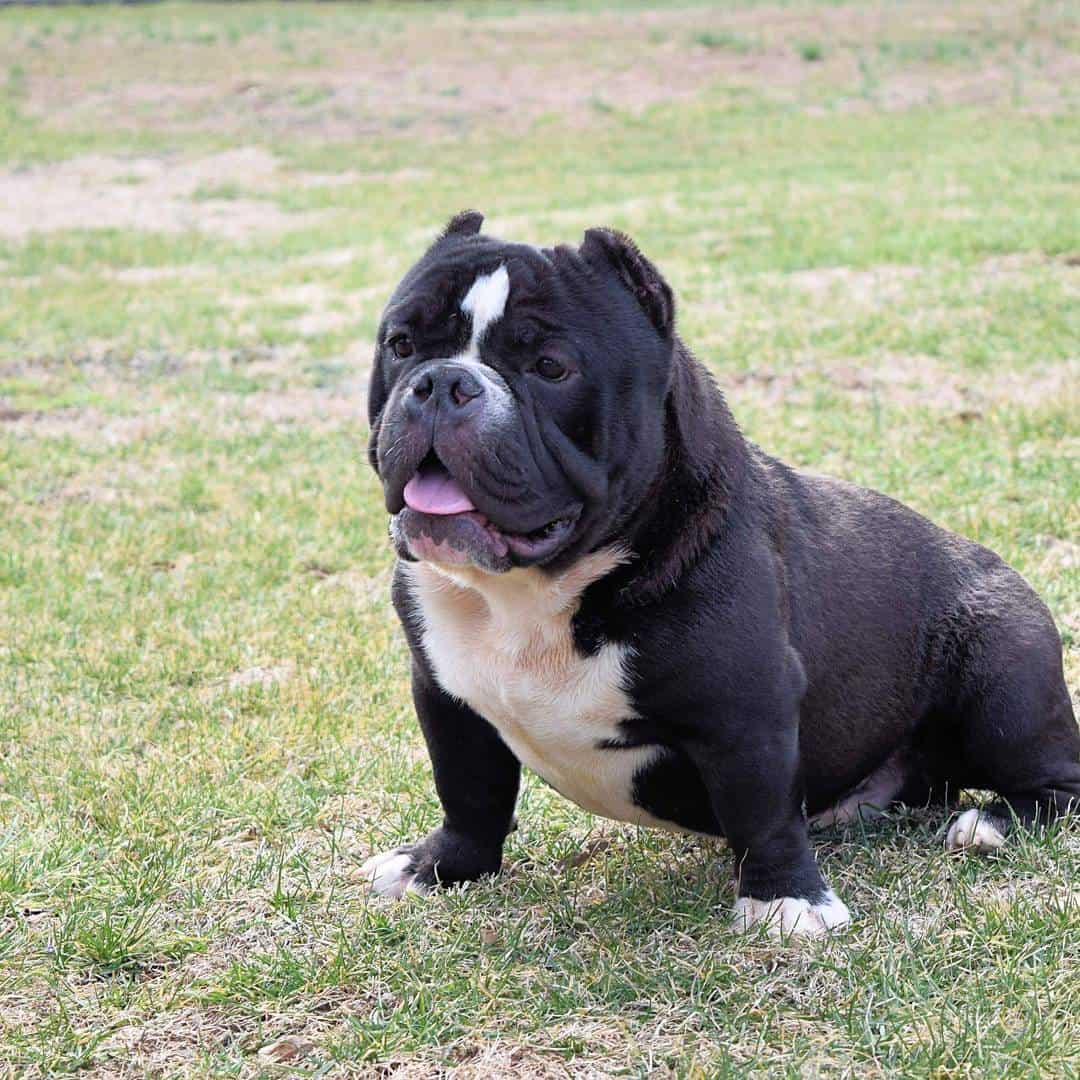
[368,213,674,572]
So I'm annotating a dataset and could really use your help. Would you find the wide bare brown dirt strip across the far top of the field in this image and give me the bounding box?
[14,3,1080,150]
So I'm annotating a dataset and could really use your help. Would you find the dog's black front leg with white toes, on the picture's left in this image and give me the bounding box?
[363,652,521,896]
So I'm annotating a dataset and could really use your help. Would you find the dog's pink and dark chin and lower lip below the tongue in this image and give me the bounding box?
[390,507,578,573]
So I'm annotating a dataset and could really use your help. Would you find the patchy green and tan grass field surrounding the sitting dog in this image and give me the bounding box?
[0,0,1080,1080]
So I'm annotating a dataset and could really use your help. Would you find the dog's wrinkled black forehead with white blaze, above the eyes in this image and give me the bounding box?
[383,238,567,324]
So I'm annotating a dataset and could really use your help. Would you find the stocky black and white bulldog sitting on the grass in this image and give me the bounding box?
[365,212,1080,935]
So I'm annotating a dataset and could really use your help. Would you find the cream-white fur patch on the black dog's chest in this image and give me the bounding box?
[406,550,675,828]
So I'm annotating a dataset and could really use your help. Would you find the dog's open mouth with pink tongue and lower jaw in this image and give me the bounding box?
[394,456,580,571]
